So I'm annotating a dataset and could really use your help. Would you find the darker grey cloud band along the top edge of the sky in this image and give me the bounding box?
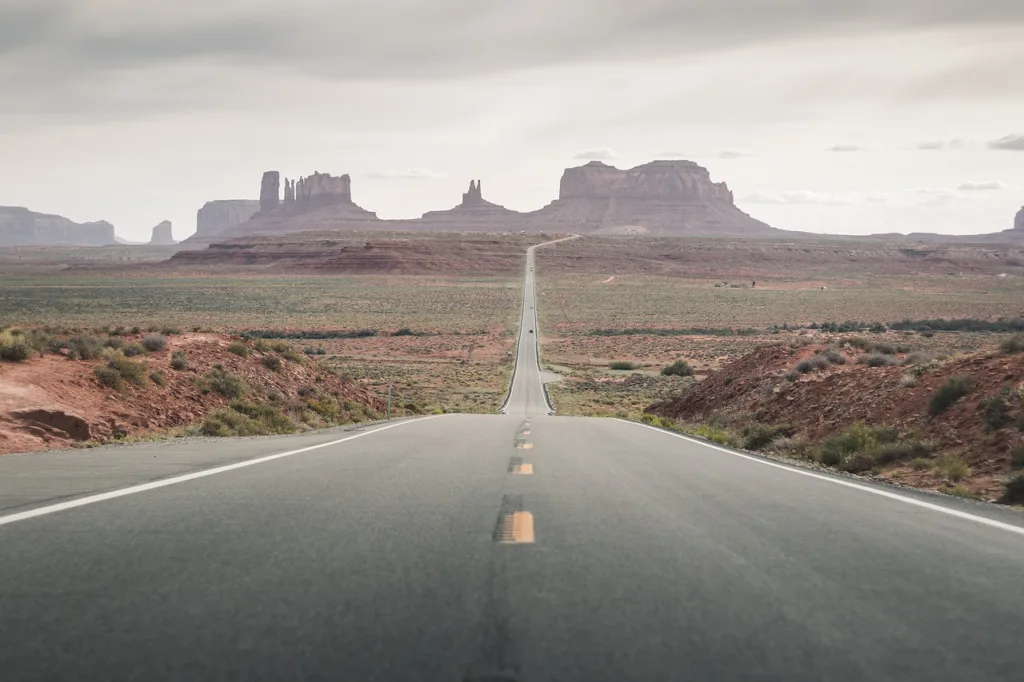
[6,0,1024,125]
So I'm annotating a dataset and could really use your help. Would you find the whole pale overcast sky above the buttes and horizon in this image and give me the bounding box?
[0,0,1024,240]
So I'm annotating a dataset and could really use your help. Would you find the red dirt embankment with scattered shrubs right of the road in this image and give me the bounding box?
[649,345,1024,498]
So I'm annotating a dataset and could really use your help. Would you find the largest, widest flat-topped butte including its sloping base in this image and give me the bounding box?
[529,161,779,236]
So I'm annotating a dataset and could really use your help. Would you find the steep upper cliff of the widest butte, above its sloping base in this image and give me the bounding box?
[558,161,733,204]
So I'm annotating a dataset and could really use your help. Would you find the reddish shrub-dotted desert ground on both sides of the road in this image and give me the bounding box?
[0,232,1024,500]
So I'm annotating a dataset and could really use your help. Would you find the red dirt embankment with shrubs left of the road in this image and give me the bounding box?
[0,334,383,455]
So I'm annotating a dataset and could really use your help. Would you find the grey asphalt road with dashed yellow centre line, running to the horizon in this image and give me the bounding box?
[0,236,1024,682]
